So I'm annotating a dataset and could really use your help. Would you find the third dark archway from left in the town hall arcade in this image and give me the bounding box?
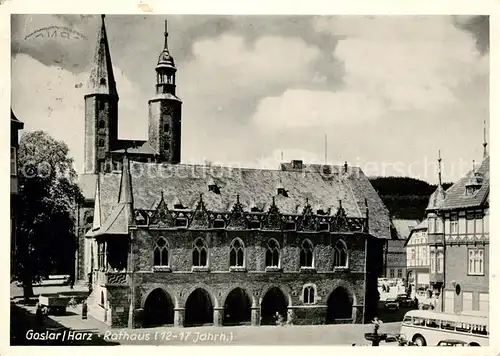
[222,287,254,325]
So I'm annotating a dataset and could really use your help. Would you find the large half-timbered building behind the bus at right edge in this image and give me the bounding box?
[438,156,490,314]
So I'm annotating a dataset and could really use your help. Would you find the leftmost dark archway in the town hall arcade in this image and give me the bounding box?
[142,287,175,327]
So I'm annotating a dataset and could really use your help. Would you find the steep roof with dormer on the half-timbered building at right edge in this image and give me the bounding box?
[440,156,490,210]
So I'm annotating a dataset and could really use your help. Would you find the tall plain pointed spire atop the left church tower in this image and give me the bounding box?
[88,15,118,97]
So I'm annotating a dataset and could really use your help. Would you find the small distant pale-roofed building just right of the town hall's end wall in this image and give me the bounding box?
[385,219,418,280]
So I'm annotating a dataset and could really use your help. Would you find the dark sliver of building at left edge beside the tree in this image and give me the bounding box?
[10,110,24,275]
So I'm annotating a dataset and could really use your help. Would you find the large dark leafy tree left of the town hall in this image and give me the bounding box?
[14,131,83,298]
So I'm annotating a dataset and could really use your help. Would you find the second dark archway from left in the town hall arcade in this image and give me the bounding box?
[184,288,214,326]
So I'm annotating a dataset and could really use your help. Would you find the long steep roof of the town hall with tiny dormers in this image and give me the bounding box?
[93,162,390,238]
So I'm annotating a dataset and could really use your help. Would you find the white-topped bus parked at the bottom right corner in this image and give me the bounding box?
[400,310,489,346]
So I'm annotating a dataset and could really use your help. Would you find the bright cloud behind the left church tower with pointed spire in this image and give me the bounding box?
[12,54,147,171]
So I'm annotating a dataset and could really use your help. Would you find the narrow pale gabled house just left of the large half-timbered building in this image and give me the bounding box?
[405,219,430,297]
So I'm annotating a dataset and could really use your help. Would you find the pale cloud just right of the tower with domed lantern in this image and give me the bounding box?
[179,34,320,105]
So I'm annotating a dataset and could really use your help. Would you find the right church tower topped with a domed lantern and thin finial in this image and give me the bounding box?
[148,20,182,164]
